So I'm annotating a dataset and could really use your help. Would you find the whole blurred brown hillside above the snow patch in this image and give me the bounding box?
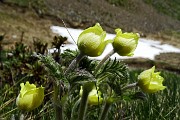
[0,0,180,47]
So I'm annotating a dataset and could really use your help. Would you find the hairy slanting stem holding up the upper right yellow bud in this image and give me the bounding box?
[94,49,115,74]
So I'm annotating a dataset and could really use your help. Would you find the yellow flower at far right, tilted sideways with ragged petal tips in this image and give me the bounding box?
[137,66,166,93]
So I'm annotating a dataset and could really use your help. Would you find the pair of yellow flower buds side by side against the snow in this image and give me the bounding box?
[77,23,139,57]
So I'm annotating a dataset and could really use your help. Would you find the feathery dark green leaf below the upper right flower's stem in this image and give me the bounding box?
[96,59,129,96]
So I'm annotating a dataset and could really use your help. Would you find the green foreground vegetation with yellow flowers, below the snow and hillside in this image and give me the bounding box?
[0,23,180,120]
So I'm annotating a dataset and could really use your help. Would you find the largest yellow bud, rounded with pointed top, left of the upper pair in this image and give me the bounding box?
[77,23,107,57]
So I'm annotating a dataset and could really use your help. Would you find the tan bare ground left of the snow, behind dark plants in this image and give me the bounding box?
[0,3,54,49]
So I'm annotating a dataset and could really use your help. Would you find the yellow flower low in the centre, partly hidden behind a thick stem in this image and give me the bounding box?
[80,86,103,105]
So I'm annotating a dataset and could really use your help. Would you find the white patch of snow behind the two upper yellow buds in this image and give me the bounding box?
[49,26,180,60]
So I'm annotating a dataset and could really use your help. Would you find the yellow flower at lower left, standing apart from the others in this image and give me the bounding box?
[16,81,44,111]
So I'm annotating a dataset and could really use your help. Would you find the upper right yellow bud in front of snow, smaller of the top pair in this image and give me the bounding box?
[113,29,139,56]
